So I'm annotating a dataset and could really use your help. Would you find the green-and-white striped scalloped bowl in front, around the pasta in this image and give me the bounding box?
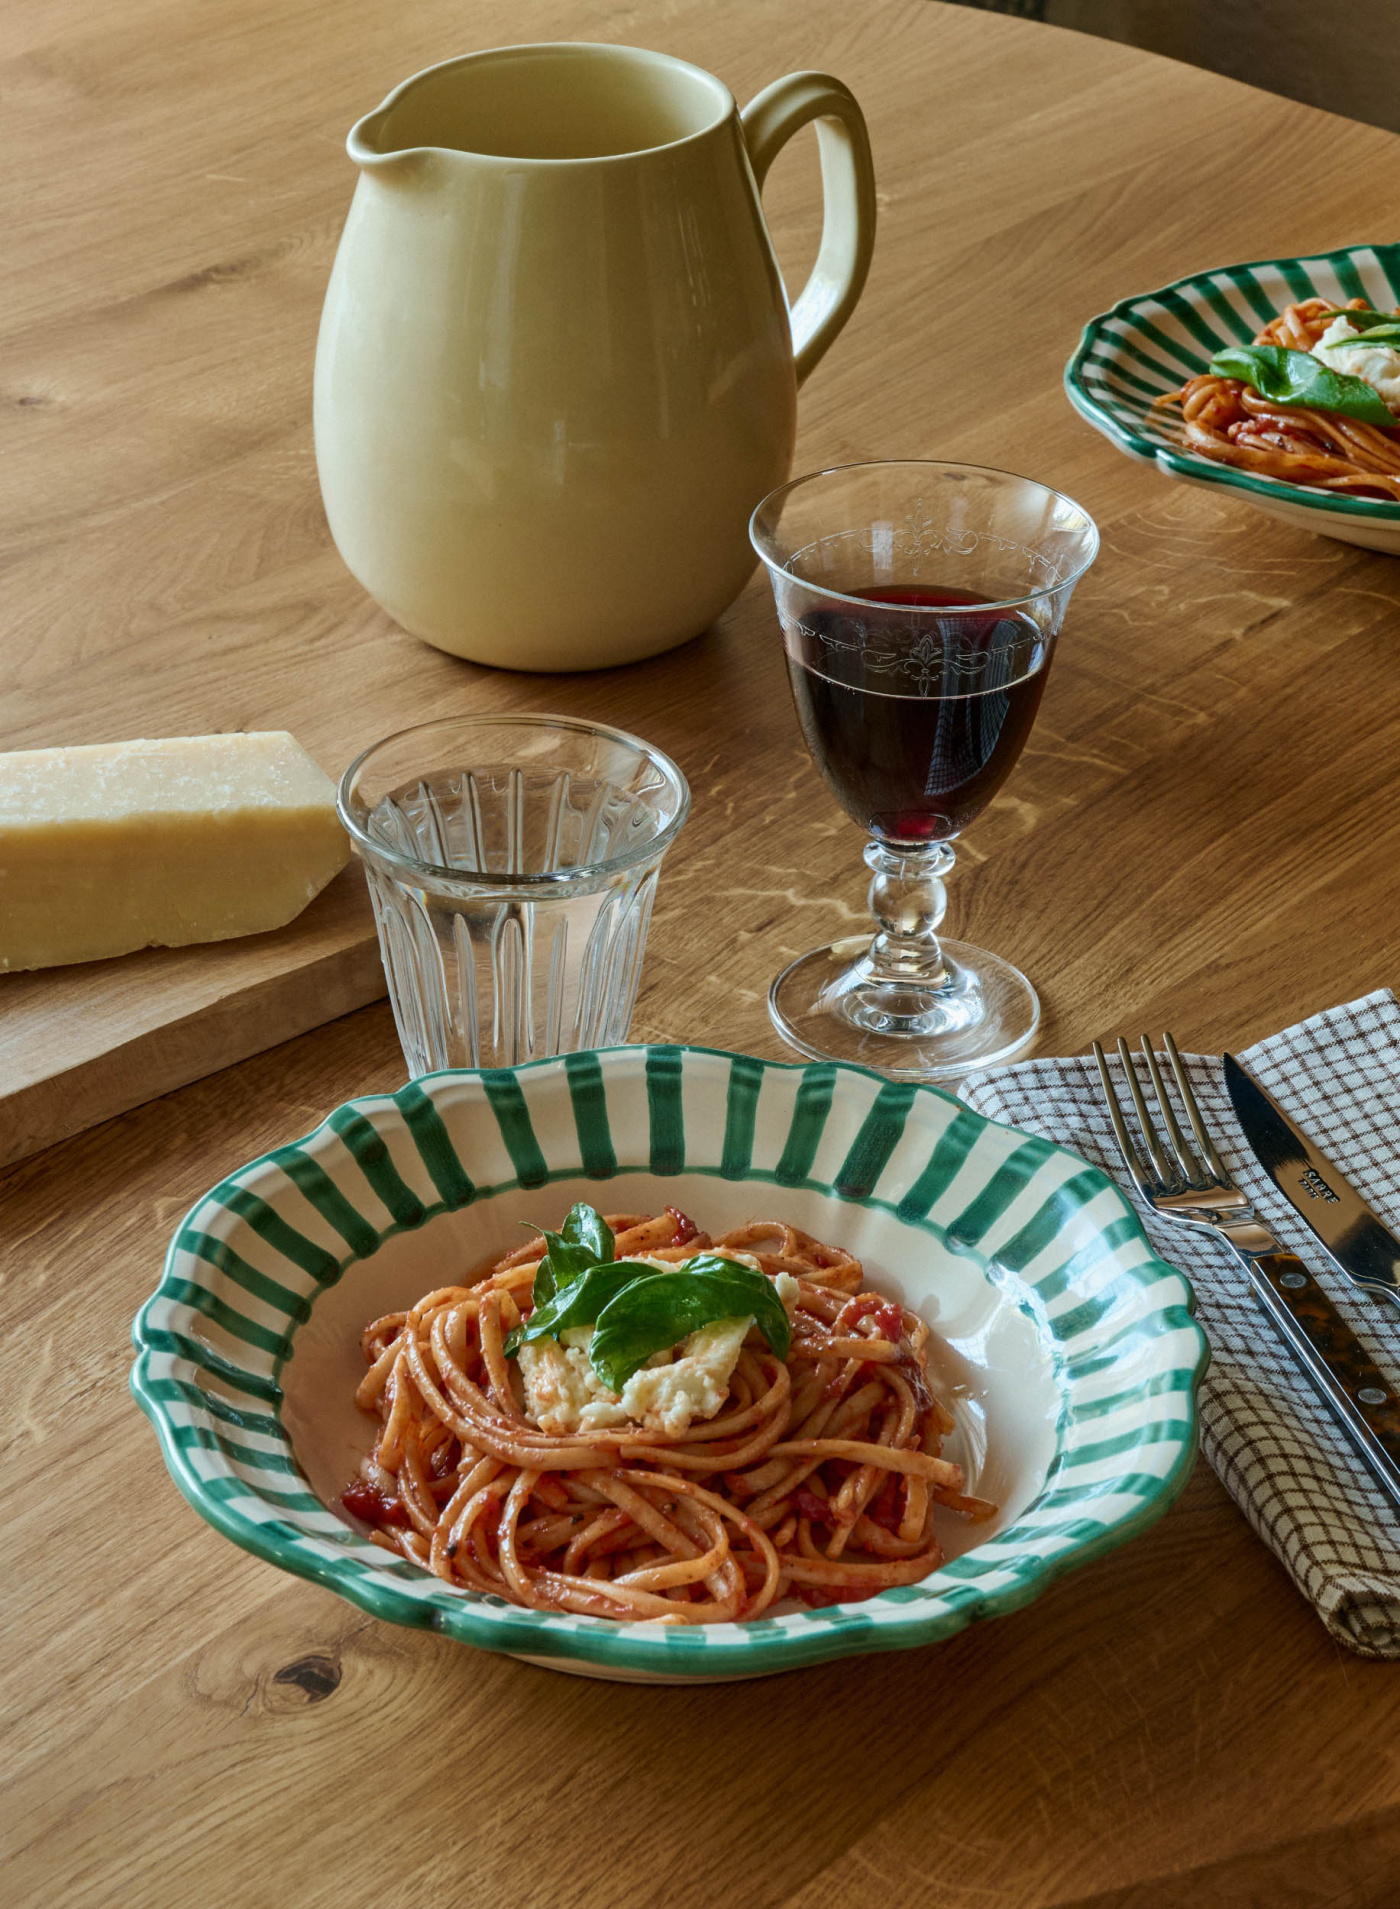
[132,1046,1207,1680]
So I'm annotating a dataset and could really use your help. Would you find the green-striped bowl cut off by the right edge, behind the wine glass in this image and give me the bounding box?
[1064,244,1400,554]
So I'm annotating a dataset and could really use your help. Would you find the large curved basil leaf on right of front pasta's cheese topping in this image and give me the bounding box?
[588,1252,791,1392]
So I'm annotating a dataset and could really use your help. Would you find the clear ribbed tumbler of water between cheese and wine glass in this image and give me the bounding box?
[338,716,689,1077]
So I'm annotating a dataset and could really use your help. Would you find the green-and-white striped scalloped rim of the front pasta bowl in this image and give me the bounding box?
[132,1044,1207,1676]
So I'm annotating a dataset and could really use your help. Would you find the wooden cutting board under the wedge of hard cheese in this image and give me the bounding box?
[0,863,384,1166]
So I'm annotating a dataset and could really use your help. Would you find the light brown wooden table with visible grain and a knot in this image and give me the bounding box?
[0,0,1400,1909]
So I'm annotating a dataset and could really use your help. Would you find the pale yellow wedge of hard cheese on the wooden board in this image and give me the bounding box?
[0,729,350,970]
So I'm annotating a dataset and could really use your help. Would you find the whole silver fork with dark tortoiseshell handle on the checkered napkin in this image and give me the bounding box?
[1094,1035,1400,1506]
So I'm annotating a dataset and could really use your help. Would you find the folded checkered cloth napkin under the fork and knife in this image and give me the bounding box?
[961,991,1400,1657]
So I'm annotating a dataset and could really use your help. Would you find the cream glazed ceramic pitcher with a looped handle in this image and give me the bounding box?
[315,44,875,670]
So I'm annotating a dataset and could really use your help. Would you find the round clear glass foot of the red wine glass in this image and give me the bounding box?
[768,941,1041,1080]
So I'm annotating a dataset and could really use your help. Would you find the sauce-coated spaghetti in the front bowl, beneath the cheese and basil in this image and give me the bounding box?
[342,1208,995,1625]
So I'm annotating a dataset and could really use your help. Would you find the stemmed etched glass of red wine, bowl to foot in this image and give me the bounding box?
[749,462,1098,1080]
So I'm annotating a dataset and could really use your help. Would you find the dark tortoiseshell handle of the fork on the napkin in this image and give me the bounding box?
[1241,1252,1400,1506]
